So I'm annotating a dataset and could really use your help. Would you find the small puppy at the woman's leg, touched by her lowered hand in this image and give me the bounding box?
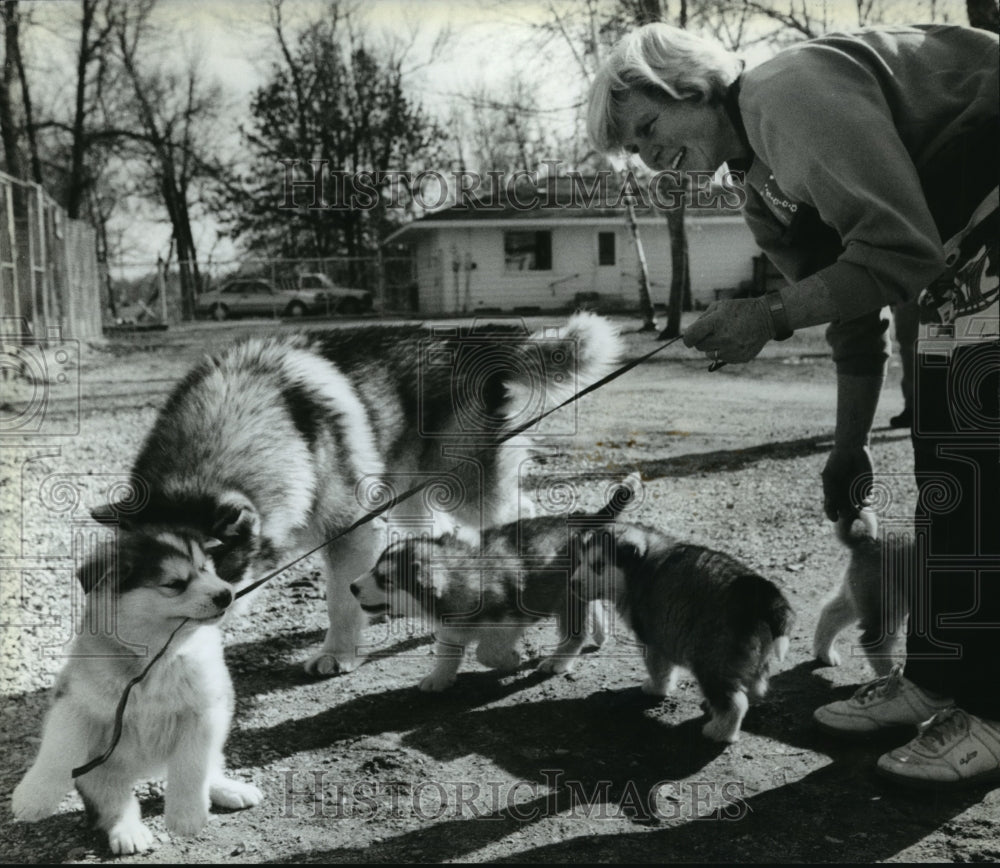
[813,509,916,675]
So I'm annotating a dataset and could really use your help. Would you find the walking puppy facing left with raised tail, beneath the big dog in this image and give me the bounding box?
[351,501,615,691]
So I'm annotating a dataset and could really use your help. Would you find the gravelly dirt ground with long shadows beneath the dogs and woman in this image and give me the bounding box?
[0,317,1000,864]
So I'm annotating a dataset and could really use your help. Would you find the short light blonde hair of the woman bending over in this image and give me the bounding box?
[587,22,743,153]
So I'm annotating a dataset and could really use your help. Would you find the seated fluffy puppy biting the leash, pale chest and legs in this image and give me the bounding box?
[12,529,262,854]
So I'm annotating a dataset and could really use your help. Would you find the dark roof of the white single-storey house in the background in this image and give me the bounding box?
[385,173,742,243]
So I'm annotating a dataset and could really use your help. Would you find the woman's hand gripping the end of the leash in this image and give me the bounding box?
[684,298,774,362]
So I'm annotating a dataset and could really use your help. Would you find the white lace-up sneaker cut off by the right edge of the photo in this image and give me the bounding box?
[877,708,1000,787]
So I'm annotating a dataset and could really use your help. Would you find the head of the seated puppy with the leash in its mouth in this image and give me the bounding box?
[79,529,233,635]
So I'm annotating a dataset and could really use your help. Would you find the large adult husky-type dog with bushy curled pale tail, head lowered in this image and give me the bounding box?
[88,314,618,675]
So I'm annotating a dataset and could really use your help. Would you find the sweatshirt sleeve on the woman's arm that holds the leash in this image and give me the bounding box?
[741,56,944,321]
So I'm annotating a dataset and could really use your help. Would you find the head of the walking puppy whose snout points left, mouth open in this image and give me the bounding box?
[351,538,436,617]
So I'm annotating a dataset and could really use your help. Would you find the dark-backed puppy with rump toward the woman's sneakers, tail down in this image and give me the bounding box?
[572,522,794,742]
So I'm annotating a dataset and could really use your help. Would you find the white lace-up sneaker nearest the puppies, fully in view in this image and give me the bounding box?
[813,664,954,736]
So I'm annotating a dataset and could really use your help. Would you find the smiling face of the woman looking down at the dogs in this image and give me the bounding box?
[618,90,742,172]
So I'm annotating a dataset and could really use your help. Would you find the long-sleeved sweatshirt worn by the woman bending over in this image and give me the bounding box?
[738,25,1000,374]
